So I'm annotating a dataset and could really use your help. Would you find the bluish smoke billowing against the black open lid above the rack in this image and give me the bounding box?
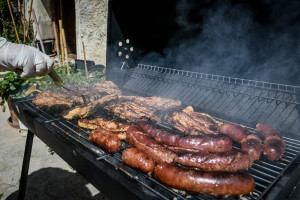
[141,0,300,84]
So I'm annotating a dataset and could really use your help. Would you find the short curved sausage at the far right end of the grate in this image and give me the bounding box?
[256,123,286,161]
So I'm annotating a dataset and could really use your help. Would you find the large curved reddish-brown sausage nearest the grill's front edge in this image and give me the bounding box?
[154,163,255,197]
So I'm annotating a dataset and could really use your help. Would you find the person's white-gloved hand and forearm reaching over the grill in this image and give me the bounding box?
[0,37,53,77]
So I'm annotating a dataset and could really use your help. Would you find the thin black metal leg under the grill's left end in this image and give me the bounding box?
[18,130,34,200]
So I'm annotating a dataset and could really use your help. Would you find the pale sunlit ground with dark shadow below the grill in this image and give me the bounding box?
[0,103,108,200]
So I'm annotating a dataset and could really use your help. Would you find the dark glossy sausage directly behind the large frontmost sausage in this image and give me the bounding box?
[176,150,253,172]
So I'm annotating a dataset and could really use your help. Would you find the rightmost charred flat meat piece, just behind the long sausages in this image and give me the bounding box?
[166,106,218,135]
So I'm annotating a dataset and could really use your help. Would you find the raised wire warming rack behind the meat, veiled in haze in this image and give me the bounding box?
[120,64,300,134]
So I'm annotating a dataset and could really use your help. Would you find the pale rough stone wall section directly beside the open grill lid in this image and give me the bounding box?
[75,0,108,65]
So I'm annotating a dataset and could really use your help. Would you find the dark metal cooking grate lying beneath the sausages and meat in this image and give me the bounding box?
[15,99,300,200]
